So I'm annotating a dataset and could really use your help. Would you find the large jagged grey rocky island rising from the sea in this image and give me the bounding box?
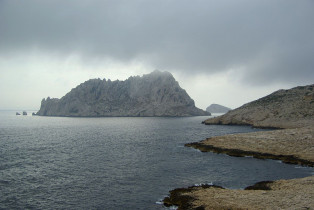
[37,71,210,117]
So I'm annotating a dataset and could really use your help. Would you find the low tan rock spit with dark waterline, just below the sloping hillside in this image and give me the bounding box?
[185,127,314,167]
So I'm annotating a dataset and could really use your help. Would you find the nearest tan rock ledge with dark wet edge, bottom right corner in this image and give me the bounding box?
[164,176,314,210]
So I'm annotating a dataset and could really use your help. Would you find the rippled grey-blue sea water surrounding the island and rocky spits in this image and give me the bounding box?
[0,111,313,209]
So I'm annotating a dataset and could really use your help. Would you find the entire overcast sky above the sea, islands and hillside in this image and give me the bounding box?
[0,0,314,110]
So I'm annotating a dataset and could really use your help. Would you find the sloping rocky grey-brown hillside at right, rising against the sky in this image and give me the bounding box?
[204,85,314,128]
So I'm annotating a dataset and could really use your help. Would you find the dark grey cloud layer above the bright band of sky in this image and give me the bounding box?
[0,0,314,85]
